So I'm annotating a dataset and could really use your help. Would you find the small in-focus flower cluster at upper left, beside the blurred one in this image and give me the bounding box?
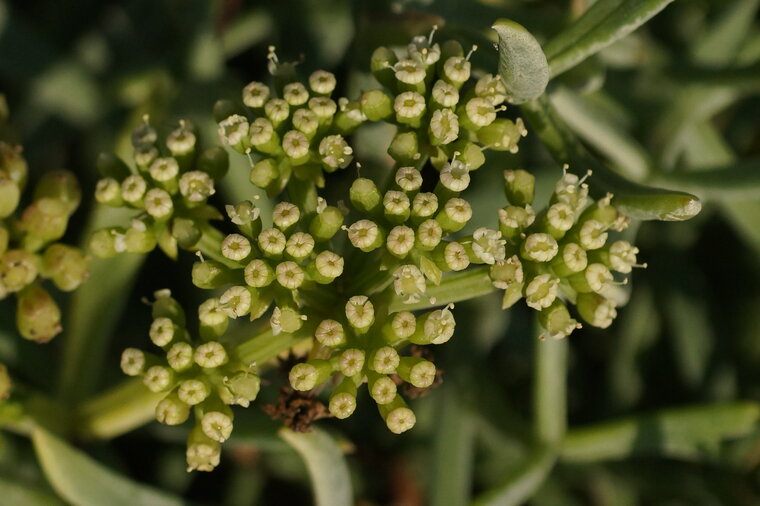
[90,116,228,258]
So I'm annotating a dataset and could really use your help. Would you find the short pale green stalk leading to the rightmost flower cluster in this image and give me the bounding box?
[390,267,495,312]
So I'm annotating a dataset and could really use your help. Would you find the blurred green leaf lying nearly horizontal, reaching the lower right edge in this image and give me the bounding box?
[561,402,760,462]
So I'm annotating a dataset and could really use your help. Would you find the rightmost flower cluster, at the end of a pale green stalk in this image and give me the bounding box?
[489,167,645,339]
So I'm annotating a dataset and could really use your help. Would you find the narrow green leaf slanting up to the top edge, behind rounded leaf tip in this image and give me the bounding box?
[544,0,673,77]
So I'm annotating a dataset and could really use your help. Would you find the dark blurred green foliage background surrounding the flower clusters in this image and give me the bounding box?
[0,0,760,506]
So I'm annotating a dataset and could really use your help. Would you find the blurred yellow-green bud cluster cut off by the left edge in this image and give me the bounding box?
[0,137,89,342]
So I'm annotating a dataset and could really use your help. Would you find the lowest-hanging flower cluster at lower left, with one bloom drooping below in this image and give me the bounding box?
[121,290,260,471]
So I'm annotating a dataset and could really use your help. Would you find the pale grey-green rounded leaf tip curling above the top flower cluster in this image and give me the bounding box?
[491,19,549,104]
